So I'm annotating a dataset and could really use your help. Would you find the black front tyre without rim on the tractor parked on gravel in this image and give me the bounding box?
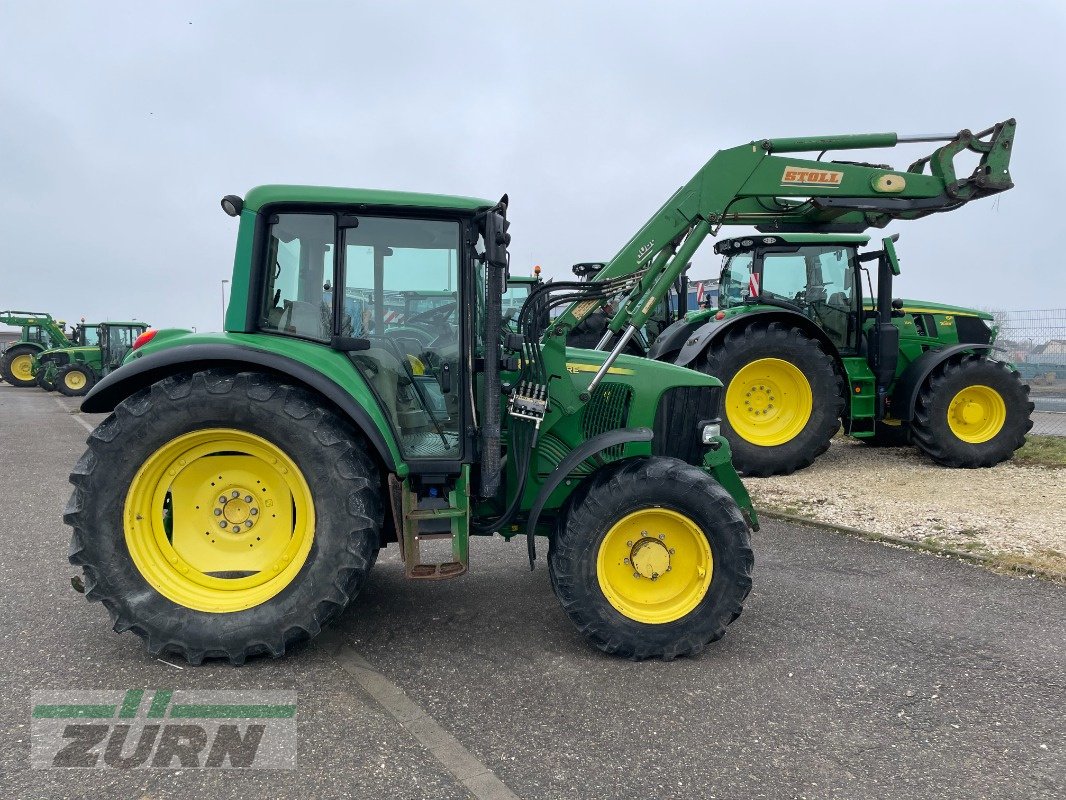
[910,355,1034,469]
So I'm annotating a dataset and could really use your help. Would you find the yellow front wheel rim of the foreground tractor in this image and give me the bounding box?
[596,508,714,625]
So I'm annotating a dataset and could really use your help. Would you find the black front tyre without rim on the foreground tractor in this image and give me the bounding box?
[548,458,754,660]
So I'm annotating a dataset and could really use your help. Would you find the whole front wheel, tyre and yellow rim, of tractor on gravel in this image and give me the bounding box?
[911,355,1033,468]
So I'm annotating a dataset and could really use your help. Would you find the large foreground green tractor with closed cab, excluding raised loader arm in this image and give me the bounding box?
[64,186,758,663]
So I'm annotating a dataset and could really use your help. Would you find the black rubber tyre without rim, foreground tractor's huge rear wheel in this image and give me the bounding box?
[64,370,382,665]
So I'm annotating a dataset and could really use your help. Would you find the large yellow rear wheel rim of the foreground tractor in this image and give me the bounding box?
[123,428,314,613]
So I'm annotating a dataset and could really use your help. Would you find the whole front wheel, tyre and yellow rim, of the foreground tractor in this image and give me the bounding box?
[548,458,753,660]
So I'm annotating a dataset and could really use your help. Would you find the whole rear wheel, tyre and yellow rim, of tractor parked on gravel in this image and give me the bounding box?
[698,322,844,478]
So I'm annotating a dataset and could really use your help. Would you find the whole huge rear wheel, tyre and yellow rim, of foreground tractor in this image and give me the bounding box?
[64,370,383,665]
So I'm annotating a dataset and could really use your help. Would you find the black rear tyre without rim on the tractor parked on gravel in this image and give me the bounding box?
[697,322,844,478]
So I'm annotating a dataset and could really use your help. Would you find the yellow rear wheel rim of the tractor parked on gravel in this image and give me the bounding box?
[725,358,814,447]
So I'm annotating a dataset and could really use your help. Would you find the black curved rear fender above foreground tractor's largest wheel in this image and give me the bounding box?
[81,342,406,474]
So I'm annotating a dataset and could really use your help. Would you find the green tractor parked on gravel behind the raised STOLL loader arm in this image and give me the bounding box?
[648,234,1033,476]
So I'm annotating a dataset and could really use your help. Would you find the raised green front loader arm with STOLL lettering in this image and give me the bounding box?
[547,119,1015,360]
